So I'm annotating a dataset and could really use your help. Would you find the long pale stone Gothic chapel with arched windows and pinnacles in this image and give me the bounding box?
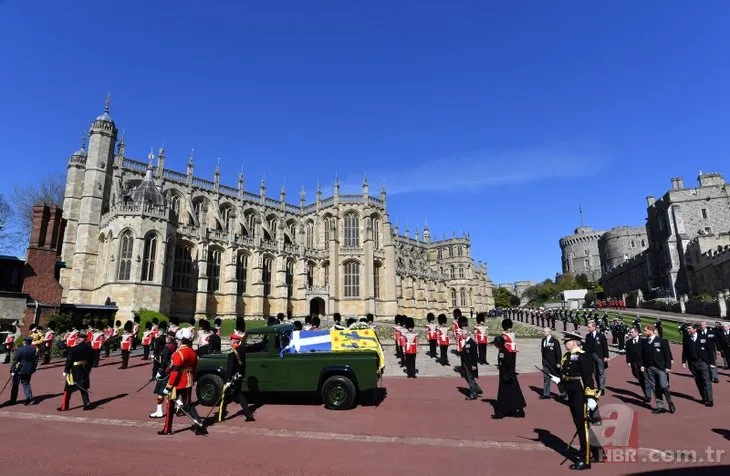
[55,102,494,320]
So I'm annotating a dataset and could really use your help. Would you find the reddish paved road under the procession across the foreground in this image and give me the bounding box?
[0,348,730,474]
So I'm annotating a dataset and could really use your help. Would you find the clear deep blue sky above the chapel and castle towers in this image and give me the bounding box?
[0,0,730,282]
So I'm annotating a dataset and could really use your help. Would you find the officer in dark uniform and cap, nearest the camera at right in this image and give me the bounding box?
[559,332,599,471]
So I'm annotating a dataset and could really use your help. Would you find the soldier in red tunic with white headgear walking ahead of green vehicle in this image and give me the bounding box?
[157,328,208,435]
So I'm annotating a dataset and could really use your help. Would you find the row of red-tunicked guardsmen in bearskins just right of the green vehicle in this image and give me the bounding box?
[393,309,489,378]
